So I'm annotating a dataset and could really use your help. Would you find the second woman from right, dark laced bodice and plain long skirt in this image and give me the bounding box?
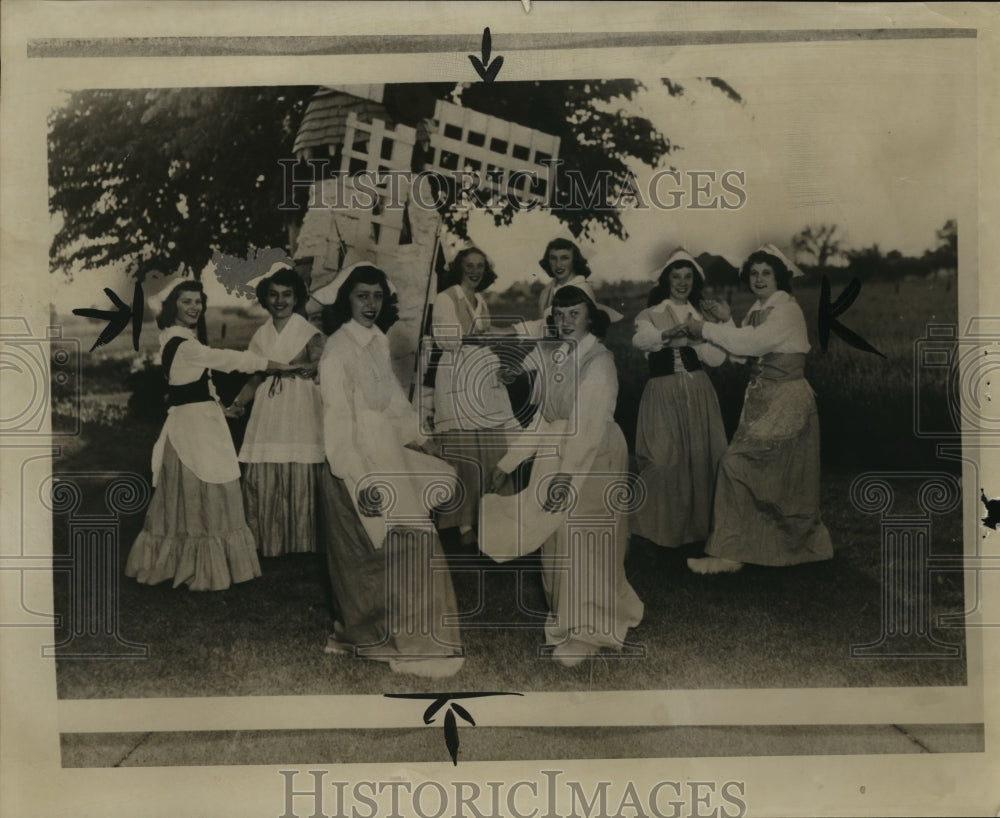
[631,249,726,548]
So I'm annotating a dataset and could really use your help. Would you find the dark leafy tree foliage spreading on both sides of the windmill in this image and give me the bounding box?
[49,78,740,276]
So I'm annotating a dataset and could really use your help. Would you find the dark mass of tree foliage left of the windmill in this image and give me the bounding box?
[49,87,315,276]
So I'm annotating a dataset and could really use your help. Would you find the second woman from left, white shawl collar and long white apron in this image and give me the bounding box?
[233,267,326,557]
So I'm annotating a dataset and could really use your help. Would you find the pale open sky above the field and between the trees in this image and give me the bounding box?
[53,52,976,309]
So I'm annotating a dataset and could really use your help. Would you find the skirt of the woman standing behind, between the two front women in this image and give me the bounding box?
[436,429,507,529]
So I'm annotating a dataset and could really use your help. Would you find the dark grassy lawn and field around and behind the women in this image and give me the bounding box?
[53,276,965,698]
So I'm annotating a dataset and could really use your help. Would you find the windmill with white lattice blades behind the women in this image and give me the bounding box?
[294,85,559,387]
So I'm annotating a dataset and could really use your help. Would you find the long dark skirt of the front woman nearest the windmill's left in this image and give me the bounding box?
[319,466,462,662]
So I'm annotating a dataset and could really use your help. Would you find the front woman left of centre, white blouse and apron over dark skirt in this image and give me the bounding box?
[314,264,464,677]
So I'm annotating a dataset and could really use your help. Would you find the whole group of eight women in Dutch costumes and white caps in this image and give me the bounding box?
[126,234,832,677]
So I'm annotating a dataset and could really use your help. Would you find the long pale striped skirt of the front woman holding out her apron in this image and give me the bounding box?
[544,423,643,652]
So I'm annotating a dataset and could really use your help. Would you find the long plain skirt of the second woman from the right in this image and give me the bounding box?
[630,370,726,548]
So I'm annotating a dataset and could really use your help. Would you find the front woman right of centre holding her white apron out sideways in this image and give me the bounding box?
[480,282,643,667]
